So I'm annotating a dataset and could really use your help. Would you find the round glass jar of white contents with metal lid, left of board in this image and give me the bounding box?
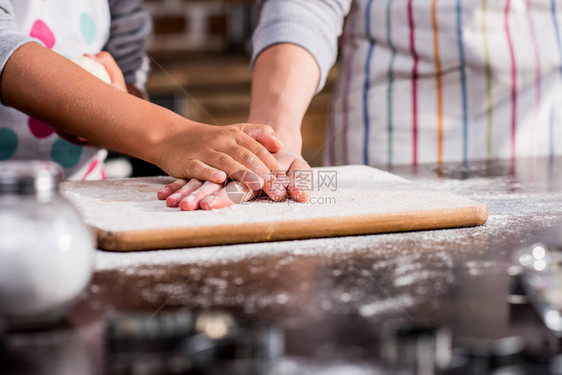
[0,161,94,327]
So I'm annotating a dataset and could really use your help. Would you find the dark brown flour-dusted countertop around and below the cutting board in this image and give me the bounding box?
[6,158,562,374]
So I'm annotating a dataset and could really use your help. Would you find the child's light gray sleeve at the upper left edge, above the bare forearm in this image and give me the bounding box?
[0,0,40,95]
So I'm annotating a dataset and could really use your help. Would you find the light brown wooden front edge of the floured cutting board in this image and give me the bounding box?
[95,204,488,252]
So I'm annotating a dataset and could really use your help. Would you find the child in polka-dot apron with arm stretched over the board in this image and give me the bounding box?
[0,0,283,201]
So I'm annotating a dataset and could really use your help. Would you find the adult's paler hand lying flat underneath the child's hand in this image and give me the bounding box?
[158,151,312,211]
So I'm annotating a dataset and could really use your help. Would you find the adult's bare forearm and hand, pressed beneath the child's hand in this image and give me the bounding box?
[159,43,320,209]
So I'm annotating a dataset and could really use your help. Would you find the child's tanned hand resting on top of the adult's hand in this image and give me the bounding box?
[157,124,287,200]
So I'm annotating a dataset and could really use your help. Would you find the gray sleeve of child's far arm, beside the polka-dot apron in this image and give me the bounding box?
[103,0,152,90]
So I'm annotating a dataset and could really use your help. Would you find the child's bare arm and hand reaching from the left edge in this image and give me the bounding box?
[0,43,281,195]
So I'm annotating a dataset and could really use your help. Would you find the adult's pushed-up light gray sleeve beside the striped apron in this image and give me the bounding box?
[252,0,352,92]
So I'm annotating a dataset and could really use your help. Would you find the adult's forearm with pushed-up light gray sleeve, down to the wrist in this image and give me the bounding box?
[249,0,351,154]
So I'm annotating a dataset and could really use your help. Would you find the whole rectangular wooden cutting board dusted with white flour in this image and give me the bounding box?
[61,166,488,251]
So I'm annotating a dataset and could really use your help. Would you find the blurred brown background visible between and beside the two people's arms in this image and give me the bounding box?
[108,0,337,176]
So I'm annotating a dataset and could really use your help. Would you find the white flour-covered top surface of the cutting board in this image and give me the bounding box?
[61,166,478,232]
